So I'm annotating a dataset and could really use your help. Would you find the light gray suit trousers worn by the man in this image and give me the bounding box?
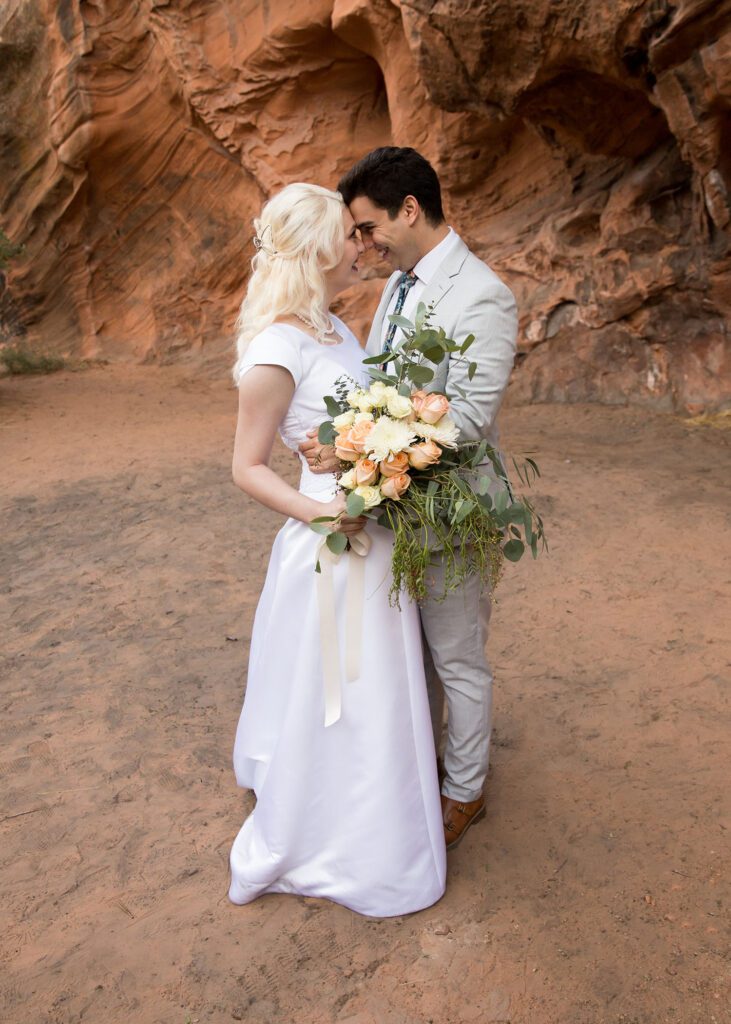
[421,561,492,803]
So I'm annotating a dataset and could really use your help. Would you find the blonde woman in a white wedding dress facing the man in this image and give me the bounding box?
[228,184,445,916]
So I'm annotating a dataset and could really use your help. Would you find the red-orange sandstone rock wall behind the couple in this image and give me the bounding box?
[0,0,731,411]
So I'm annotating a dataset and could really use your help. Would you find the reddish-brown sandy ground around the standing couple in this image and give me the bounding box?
[0,368,731,1024]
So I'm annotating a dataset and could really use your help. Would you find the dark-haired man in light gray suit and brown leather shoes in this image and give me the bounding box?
[302,146,517,849]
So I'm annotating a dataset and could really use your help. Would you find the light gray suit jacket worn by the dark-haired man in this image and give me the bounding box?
[366,239,511,447]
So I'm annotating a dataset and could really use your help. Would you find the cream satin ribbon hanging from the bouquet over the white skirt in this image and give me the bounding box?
[316,530,371,728]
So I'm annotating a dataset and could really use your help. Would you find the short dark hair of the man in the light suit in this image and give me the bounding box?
[338,145,444,227]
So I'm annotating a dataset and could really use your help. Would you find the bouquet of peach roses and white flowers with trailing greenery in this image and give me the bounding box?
[311,303,546,604]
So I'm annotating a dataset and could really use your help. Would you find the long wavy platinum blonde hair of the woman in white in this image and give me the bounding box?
[233,182,345,384]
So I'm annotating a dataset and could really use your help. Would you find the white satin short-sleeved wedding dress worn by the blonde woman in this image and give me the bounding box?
[228,318,445,916]
